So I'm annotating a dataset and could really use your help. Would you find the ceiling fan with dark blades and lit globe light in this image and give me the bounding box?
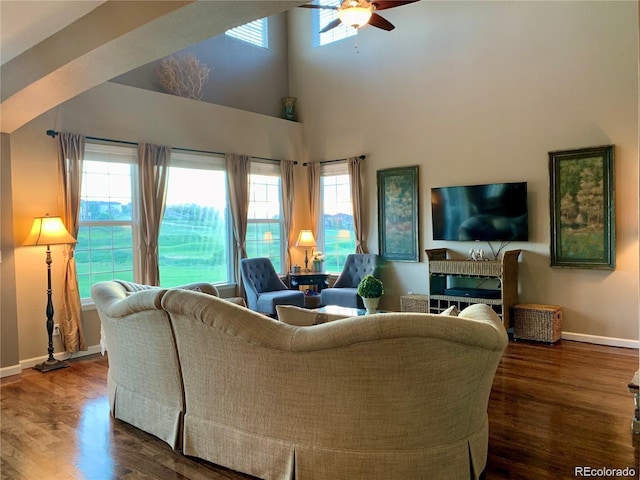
[300,0,419,33]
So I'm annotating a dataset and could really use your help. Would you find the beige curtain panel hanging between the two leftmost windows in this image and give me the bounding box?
[138,143,171,285]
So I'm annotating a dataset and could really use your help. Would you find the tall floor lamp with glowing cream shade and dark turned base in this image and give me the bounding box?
[22,215,76,373]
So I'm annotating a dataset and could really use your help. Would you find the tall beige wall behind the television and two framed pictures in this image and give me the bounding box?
[290,1,639,341]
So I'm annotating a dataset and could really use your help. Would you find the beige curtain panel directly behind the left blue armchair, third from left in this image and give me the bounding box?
[225,153,251,297]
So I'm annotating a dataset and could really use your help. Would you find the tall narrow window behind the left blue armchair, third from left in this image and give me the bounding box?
[247,162,284,273]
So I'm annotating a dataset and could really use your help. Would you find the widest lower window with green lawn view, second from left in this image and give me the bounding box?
[158,150,231,287]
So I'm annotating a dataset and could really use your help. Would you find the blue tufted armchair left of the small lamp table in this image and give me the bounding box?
[240,258,304,316]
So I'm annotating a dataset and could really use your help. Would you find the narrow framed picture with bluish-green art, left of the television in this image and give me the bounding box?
[377,165,420,262]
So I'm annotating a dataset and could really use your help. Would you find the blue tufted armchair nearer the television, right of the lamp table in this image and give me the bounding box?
[320,253,380,308]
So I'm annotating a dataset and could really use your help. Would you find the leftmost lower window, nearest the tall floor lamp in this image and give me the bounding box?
[75,144,139,298]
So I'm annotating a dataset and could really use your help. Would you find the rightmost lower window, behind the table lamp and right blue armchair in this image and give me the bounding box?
[319,162,356,272]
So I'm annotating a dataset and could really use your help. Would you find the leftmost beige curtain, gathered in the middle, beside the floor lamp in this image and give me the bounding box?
[58,133,87,352]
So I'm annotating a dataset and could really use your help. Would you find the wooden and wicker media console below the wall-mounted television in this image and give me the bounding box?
[425,248,520,329]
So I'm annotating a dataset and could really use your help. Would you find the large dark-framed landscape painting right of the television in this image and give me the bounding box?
[549,145,615,270]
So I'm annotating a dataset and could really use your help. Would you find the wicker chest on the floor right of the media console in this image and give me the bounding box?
[513,303,562,343]
